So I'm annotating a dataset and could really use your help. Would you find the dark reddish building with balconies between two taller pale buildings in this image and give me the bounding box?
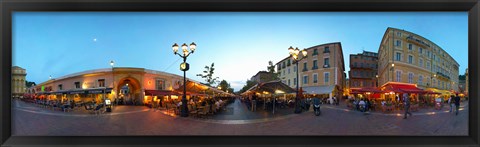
[348,51,378,88]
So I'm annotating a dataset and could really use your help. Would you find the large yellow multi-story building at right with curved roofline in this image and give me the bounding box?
[378,27,459,94]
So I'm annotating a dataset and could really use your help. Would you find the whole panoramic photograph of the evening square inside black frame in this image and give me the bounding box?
[11,12,469,136]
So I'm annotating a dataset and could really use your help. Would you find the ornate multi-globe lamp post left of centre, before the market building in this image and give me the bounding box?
[172,42,197,117]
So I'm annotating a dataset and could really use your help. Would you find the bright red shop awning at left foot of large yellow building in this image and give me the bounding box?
[381,82,425,93]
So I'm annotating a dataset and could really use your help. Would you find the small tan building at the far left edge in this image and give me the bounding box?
[12,66,27,97]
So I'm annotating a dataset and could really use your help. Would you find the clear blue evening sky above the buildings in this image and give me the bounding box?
[13,12,468,91]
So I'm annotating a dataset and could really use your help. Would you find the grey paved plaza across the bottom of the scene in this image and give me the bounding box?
[12,100,468,136]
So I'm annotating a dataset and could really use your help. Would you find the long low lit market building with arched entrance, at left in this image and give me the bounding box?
[29,67,230,105]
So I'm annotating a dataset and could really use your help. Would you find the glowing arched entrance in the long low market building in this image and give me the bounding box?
[116,77,142,105]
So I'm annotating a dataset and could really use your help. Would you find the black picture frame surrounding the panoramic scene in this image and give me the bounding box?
[0,0,480,146]
